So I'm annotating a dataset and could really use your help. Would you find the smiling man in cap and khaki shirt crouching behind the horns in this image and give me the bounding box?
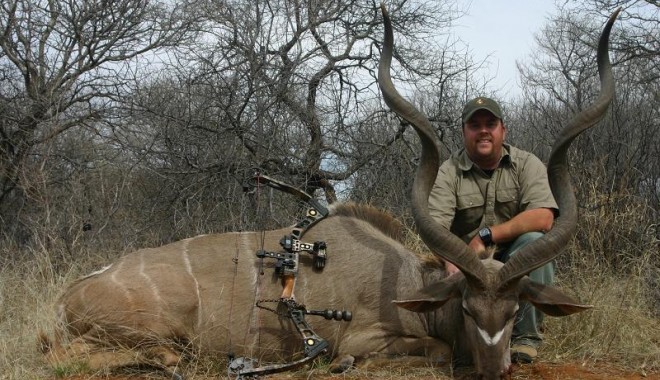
[429,97,557,363]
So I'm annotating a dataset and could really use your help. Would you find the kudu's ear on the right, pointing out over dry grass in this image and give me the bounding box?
[518,277,593,317]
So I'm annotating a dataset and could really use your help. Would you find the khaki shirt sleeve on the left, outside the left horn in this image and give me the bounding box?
[429,160,456,229]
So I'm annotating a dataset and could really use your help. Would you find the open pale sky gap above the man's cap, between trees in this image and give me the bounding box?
[456,0,556,96]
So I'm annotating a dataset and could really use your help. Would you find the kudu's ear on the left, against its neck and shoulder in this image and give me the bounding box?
[392,273,465,313]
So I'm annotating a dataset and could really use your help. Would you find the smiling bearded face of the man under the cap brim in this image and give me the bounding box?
[463,110,506,169]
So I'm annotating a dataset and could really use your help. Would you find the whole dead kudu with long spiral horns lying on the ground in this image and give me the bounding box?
[41,3,614,378]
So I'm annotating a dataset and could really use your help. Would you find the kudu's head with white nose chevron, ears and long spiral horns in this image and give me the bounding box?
[378,4,619,379]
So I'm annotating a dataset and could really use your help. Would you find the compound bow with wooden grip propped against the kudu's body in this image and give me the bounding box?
[227,174,353,379]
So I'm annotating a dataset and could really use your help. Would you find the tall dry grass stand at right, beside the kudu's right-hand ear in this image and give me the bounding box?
[545,184,660,372]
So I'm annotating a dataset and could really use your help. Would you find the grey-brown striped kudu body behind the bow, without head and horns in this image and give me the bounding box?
[44,204,450,369]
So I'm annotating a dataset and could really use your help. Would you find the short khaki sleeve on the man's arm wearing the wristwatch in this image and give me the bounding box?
[520,154,559,215]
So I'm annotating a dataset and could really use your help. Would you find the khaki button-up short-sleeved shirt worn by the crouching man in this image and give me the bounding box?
[429,144,558,242]
